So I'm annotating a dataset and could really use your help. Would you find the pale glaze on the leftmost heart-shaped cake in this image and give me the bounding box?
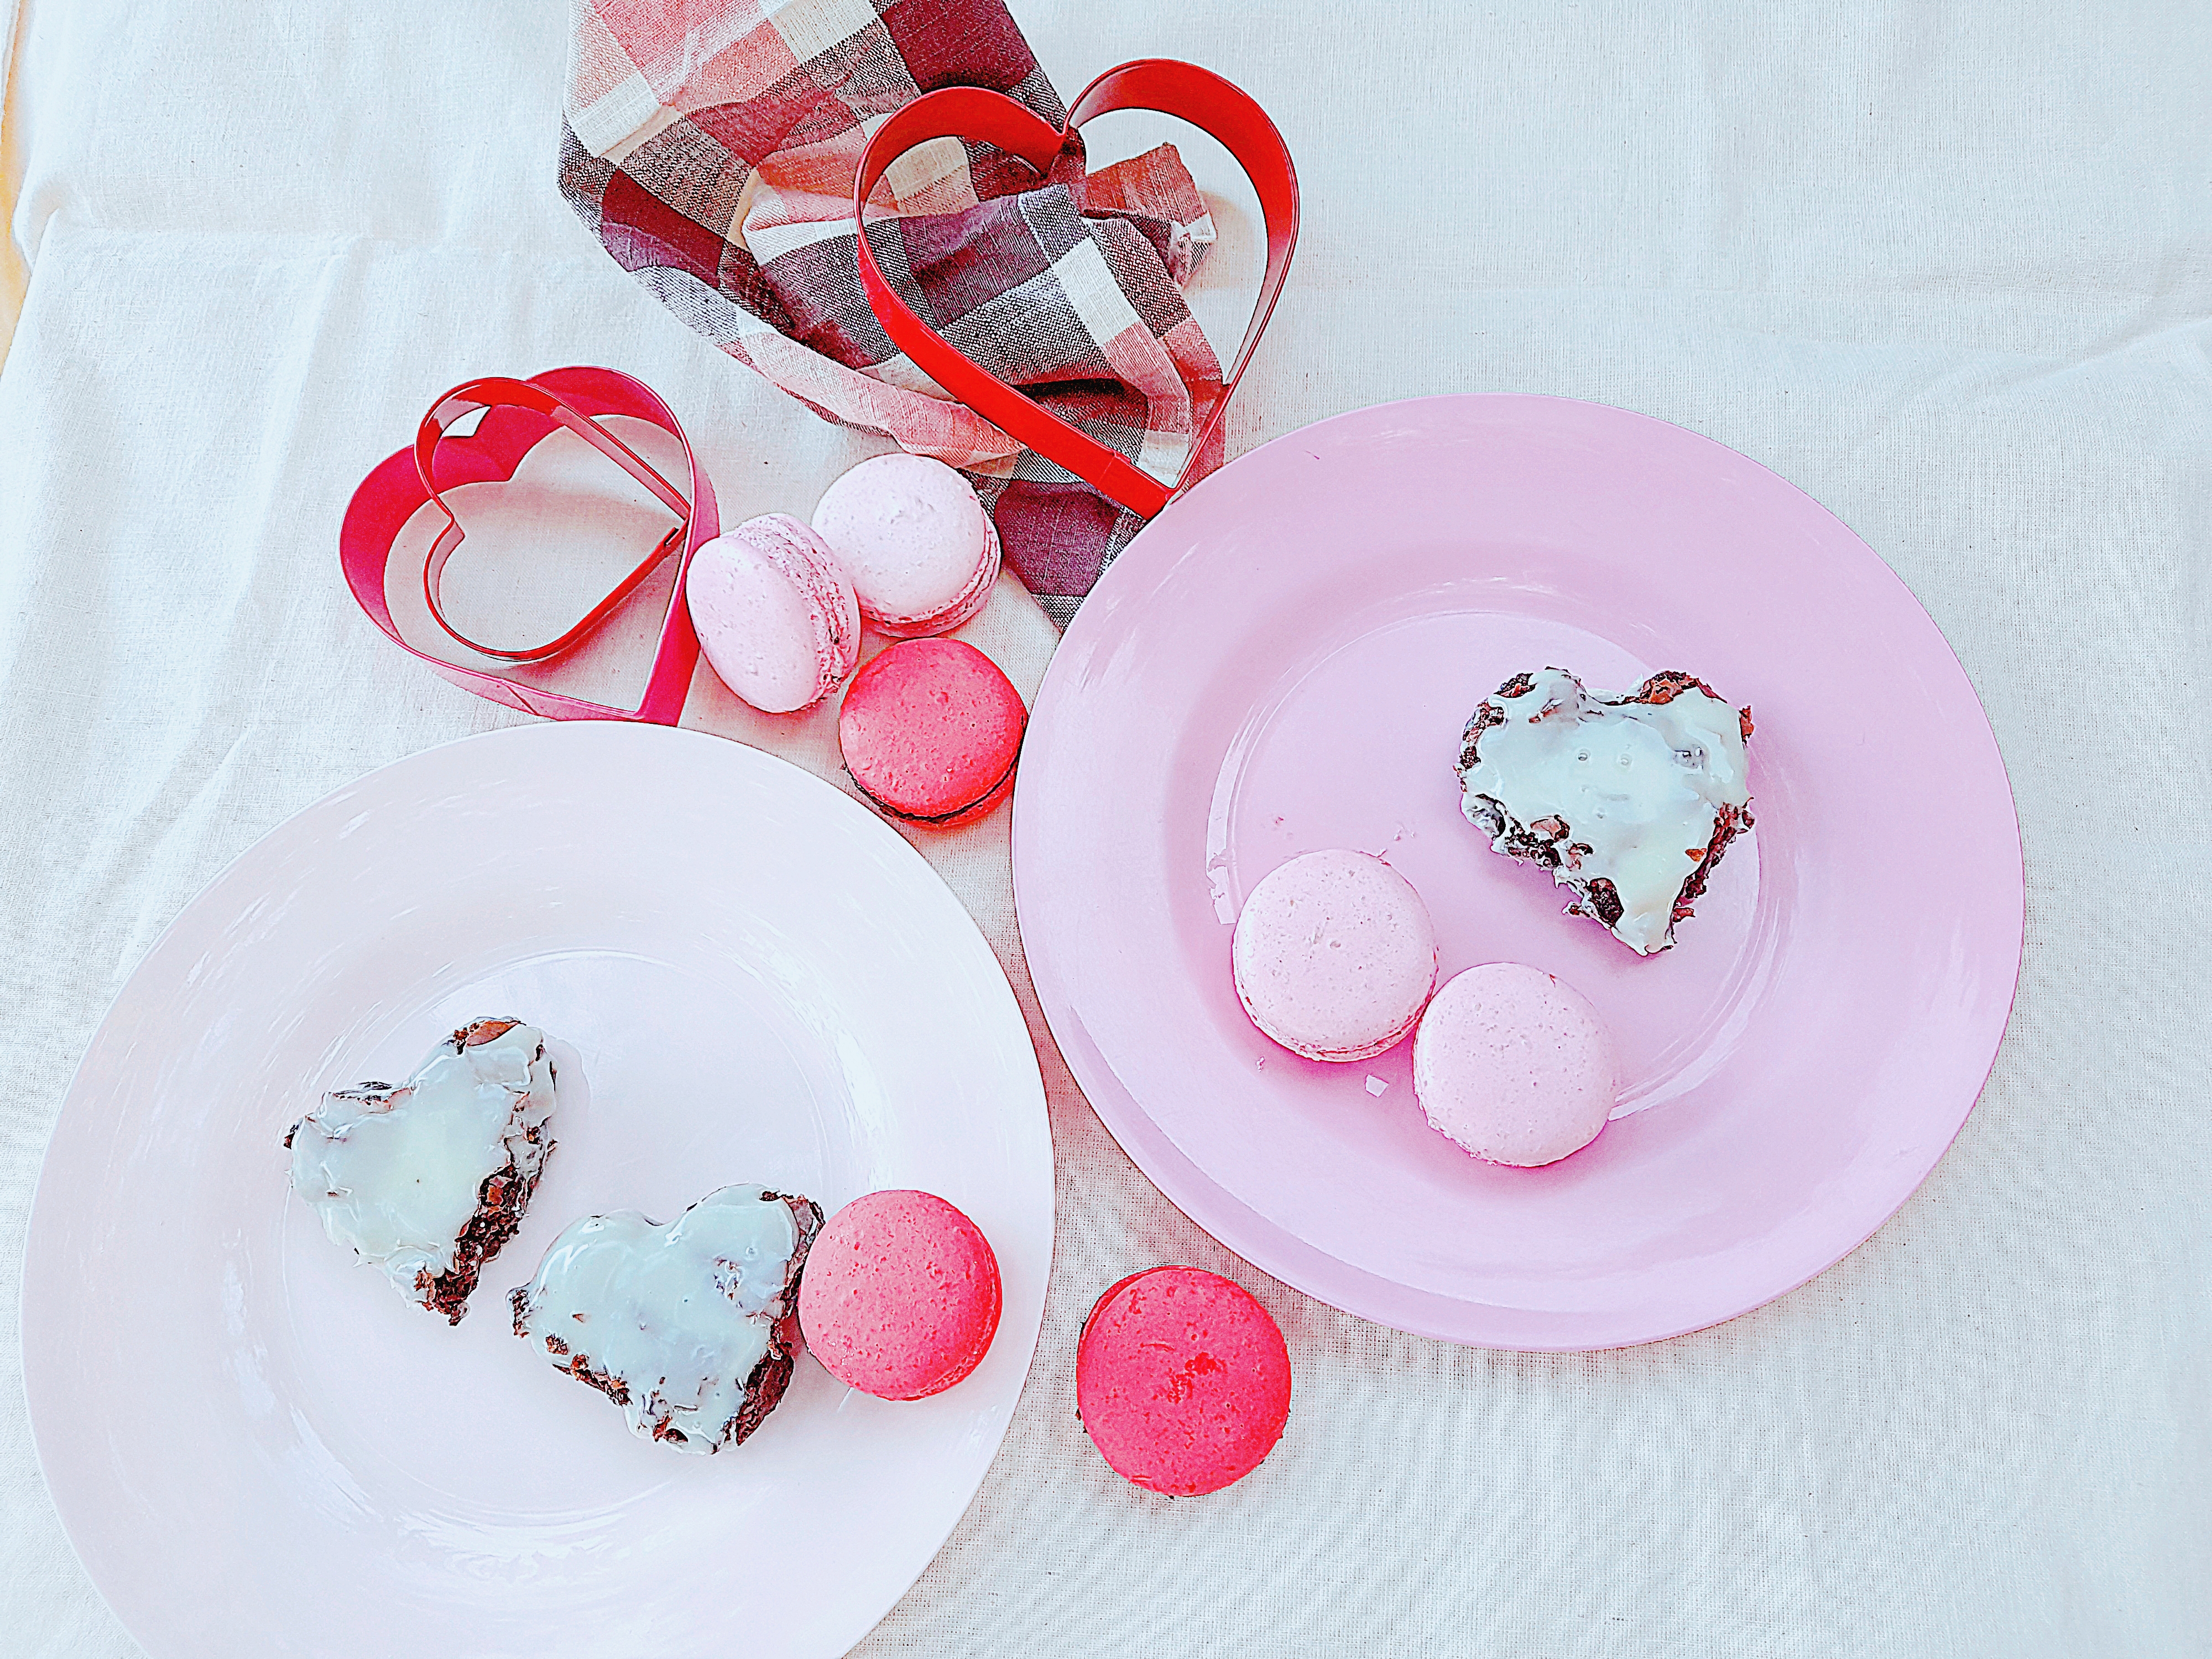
[290,1020,555,1301]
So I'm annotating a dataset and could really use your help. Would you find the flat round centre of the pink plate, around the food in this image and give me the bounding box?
[1203,593,1778,1115]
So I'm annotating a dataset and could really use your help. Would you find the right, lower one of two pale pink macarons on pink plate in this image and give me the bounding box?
[1413,962,1619,1168]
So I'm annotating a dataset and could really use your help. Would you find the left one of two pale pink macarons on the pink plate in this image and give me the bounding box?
[1230,847,1436,1060]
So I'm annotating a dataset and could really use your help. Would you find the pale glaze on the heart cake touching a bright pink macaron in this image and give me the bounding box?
[513,1186,812,1451]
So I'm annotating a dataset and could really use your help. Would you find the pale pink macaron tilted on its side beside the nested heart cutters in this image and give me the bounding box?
[684,513,860,714]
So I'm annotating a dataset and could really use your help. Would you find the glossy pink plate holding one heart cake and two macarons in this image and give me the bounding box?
[1013,396,2022,1349]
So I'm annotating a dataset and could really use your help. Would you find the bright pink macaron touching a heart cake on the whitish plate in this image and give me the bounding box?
[799,1192,1000,1400]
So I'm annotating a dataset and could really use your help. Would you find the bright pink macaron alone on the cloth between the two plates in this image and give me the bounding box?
[1075,1267,1290,1498]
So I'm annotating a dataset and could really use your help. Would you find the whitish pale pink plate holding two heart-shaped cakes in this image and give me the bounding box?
[22,723,1053,1659]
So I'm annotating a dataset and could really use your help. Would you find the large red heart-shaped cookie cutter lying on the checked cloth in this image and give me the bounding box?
[852,58,1298,518]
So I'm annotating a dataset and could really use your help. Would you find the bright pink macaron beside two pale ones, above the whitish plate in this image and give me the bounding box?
[836,639,1029,825]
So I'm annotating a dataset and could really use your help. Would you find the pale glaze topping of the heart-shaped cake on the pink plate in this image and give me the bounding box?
[1460,668,1752,956]
